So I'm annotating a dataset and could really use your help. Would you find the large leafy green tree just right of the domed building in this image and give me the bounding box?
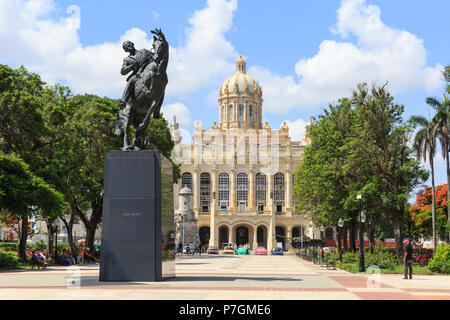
[294,84,428,258]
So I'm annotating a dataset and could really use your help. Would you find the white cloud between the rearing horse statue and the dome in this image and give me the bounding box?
[167,0,237,95]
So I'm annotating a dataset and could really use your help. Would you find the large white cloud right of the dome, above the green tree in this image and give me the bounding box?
[249,0,442,113]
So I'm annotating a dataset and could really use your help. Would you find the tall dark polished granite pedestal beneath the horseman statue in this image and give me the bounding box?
[100,151,175,281]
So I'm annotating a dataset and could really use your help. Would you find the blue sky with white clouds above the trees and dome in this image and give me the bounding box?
[0,0,450,190]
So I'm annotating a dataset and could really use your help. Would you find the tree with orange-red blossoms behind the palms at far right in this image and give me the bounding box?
[409,184,449,239]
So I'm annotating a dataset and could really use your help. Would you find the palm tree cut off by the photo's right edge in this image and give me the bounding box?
[426,96,450,239]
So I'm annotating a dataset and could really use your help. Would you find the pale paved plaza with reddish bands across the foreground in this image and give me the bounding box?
[0,255,450,300]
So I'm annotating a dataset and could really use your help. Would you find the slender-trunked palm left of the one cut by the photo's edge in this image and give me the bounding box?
[410,116,437,248]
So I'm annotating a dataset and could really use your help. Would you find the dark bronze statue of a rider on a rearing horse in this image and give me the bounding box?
[114,29,169,151]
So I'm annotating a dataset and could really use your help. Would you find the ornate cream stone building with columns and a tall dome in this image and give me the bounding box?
[171,57,319,250]
